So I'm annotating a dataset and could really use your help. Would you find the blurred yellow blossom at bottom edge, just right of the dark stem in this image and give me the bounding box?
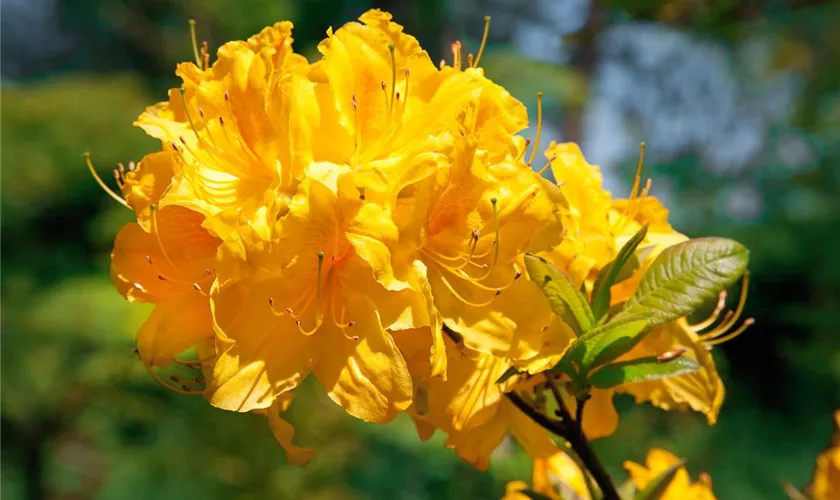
[624,448,715,500]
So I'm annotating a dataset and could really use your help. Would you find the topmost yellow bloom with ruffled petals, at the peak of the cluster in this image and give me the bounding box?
[309,10,476,197]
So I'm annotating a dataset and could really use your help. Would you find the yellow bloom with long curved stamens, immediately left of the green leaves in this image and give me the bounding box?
[402,135,561,358]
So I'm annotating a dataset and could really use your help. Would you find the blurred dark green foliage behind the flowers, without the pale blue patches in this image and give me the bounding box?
[0,0,840,499]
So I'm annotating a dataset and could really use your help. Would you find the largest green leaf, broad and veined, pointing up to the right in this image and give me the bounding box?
[619,238,749,327]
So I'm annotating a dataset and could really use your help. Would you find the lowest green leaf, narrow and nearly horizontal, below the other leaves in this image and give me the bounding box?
[589,356,700,389]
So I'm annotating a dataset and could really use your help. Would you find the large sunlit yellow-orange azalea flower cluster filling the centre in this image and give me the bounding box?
[97,10,741,467]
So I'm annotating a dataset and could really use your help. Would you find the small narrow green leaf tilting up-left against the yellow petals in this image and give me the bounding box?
[525,254,595,335]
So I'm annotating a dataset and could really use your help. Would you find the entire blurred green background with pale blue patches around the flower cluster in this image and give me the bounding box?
[0,0,840,499]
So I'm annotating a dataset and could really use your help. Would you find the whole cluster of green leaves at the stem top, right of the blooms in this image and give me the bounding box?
[524,226,749,392]
